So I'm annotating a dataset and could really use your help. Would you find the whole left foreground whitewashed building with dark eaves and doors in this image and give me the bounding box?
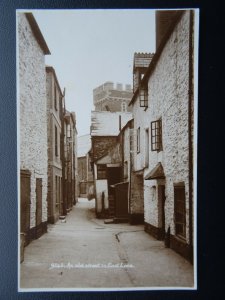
[17,13,50,244]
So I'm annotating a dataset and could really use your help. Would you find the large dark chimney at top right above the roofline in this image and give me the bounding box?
[155,10,177,49]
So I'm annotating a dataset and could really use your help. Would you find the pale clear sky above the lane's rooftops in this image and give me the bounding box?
[31,9,155,136]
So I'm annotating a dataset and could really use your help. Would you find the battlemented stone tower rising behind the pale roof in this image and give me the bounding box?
[93,81,133,112]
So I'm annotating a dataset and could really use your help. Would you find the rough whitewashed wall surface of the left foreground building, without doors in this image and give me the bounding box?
[18,13,48,228]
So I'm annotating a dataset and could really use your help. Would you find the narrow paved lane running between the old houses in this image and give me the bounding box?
[20,198,193,289]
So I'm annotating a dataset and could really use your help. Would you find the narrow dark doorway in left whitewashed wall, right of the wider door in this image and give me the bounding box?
[36,178,42,238]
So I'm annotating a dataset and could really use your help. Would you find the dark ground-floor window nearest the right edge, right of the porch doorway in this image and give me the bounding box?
[174,185,186,238]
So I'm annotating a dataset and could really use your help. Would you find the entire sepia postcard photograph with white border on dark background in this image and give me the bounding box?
[16,8,199,292]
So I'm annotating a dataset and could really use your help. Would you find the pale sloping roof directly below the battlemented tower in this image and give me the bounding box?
[91,111,133,136]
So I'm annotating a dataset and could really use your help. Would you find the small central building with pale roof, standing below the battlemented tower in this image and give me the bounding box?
[90,111,132,217]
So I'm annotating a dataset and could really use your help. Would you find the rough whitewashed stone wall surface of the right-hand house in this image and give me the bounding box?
[133,11,190,243]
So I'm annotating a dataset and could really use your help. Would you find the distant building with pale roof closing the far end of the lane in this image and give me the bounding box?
[77,134,94,197]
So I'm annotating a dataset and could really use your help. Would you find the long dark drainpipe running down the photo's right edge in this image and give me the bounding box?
[188,10,194,261]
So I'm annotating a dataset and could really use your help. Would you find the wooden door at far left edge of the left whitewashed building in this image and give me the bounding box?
[20,170,30,244]
